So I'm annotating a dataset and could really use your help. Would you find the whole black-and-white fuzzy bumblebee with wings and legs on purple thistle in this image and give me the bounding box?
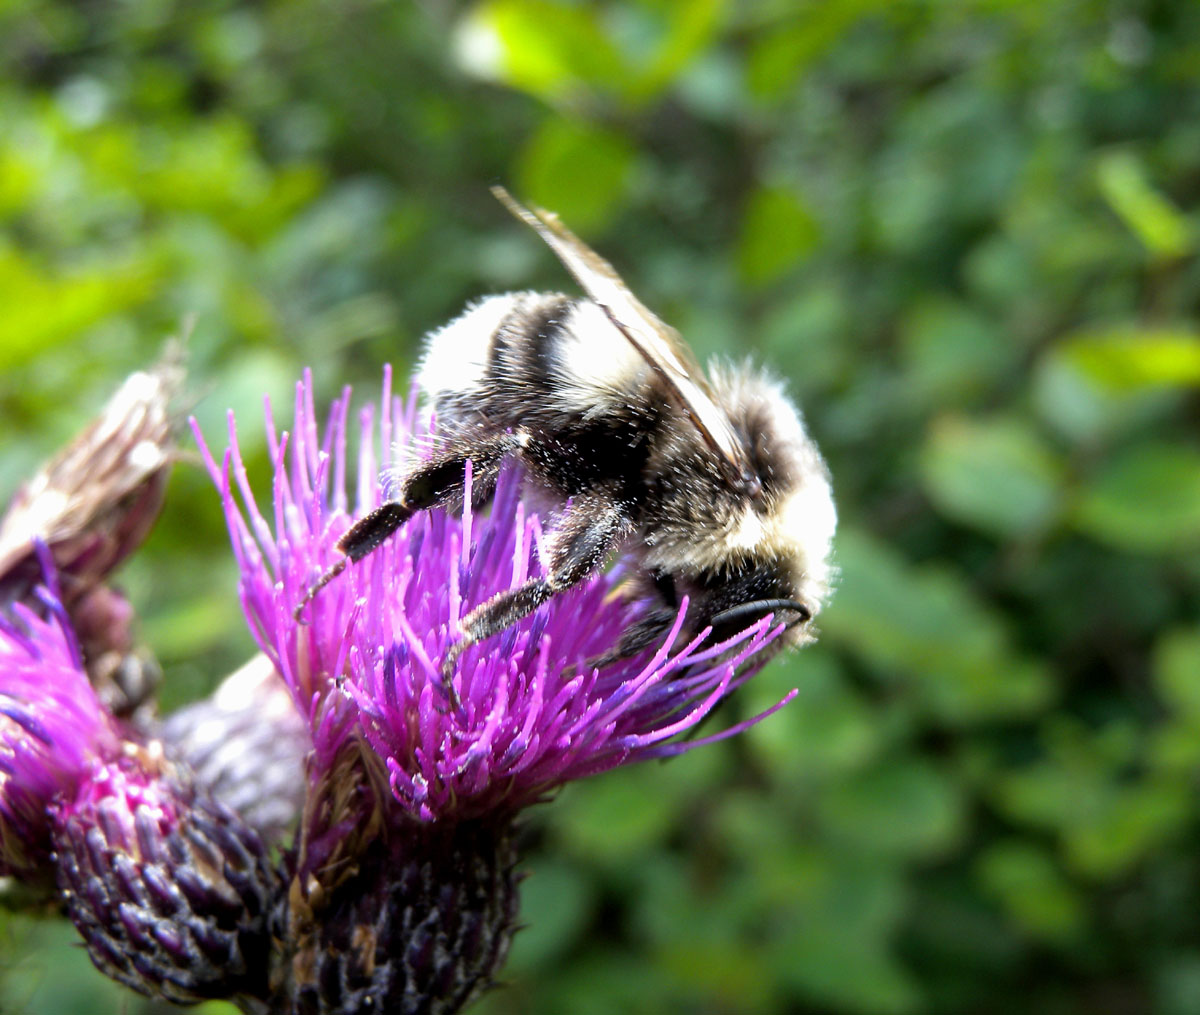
[298,187,836,674]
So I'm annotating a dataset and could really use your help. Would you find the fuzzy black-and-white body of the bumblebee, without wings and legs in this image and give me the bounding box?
[403,292,836,657]
